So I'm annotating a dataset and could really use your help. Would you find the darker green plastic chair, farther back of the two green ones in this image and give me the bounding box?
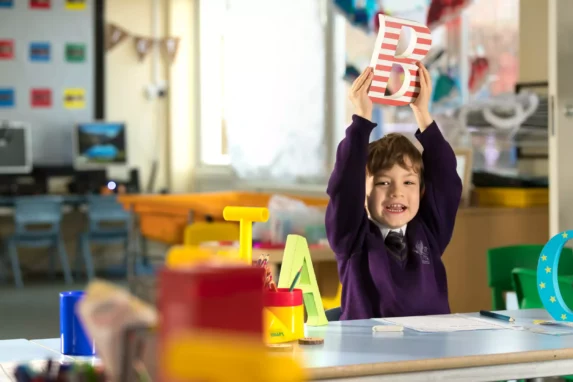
[487,244,573,310]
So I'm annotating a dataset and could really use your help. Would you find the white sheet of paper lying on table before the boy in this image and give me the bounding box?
[377,314,504,332]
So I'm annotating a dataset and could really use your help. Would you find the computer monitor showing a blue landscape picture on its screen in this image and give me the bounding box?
[73,122,127,169]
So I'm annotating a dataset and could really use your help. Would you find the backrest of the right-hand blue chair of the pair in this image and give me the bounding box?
[87,195,131,232]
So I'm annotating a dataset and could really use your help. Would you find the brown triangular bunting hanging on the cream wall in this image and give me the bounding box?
[106,23,181,63]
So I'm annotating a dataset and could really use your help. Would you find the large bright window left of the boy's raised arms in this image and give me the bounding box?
[200,0,335,183]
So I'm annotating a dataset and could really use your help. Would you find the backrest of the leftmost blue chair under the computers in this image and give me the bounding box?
[14,195,63,234]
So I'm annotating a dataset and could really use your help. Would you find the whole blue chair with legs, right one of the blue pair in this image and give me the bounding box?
[76,195,131,280]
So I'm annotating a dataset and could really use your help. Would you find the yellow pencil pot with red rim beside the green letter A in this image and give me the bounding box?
[263,288,304,344]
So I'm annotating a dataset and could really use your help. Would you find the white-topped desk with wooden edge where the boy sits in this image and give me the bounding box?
[0,309,573,382]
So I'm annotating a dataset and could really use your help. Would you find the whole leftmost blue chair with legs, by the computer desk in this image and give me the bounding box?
[5,196,73,288]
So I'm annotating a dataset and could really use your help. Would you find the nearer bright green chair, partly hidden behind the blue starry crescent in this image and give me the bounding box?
[511,268,573,381]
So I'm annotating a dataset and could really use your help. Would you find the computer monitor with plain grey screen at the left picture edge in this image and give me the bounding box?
[0,121,32,174]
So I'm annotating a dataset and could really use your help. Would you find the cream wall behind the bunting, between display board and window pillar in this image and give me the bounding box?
[105,0,168,190]
